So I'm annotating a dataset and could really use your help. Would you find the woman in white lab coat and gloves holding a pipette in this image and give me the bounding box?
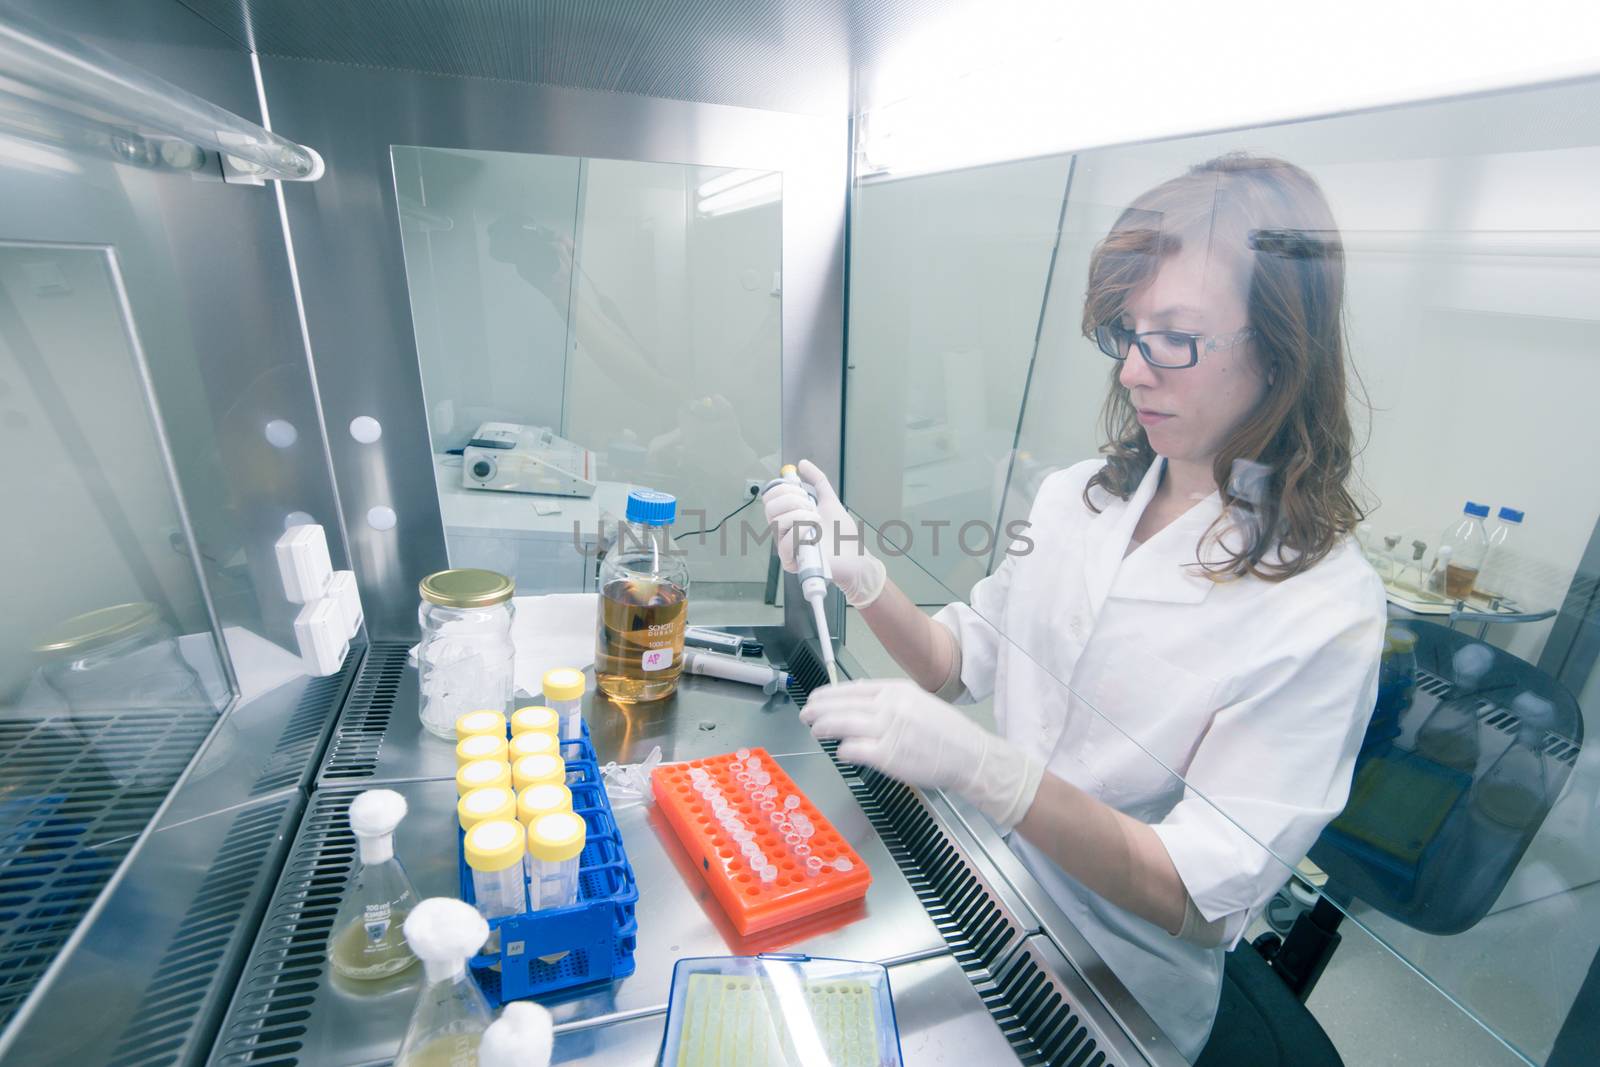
[765,155,1386,1061]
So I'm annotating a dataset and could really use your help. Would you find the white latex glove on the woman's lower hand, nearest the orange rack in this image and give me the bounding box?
[800,678,1045,833]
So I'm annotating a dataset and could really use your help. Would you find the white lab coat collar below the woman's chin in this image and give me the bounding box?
[1085,458,1222,614]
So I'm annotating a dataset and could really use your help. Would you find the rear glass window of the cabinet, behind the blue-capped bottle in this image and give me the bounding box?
[392,147,782,621]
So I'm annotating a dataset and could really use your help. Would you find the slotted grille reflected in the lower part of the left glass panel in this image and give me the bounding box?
[0,709,216,1027]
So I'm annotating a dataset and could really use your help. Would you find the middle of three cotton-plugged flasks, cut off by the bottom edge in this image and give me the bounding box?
[395,897,494,1067]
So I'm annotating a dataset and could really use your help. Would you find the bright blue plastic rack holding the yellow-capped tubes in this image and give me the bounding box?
[456,723,638,1006]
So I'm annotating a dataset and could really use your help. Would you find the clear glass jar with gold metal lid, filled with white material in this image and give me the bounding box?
[416,568,517,742]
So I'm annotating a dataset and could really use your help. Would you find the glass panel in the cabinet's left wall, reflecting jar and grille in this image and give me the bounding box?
[0,243,232,1025]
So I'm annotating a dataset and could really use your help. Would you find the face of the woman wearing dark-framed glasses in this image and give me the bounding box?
[1118,248,1267,466]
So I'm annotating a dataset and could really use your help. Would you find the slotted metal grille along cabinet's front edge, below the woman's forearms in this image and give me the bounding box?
[787,646,1107,1067]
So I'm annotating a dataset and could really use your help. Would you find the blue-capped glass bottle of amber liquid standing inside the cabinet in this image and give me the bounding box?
[595,490,690,704]
